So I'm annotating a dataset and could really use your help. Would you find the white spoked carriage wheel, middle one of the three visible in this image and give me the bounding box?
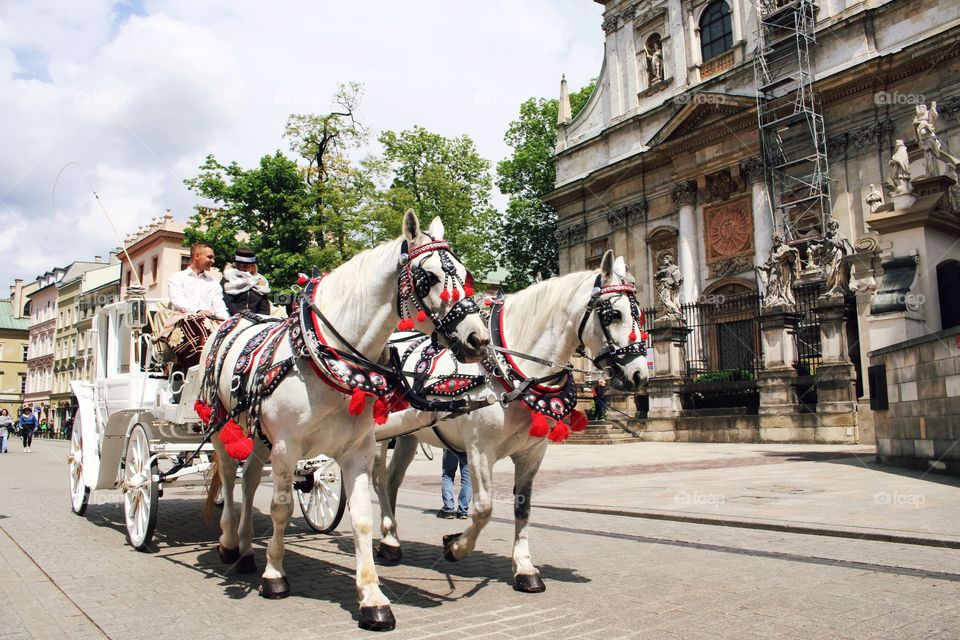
[123,424,160,551]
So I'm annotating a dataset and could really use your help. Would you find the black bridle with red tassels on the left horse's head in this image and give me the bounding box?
[397,237,480,359]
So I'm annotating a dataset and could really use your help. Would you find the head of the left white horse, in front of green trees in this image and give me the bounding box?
[397,210,490,362]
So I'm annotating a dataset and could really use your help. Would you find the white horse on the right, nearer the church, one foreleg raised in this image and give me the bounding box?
[374,251,648,593]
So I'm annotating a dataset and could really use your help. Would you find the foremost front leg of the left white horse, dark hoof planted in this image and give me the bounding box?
[338,444,397,631]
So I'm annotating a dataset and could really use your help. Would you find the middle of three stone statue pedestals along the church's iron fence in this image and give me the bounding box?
[757,305,814,442]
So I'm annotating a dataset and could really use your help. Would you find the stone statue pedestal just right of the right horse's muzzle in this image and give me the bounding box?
[643,318,690,442]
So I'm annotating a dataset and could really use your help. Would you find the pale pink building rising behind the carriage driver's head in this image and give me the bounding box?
[120,209,190,300]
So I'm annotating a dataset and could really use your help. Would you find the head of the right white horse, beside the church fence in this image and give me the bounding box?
[580,251,649,391]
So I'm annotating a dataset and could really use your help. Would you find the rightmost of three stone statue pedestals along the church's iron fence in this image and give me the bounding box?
[814,297,858,443]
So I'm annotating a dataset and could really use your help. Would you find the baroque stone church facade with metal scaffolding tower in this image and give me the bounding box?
[543,0,960,464]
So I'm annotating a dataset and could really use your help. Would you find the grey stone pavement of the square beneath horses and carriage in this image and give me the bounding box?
[0,442,960,640]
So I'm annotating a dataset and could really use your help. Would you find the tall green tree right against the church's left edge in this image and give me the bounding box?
[496,80,596,290]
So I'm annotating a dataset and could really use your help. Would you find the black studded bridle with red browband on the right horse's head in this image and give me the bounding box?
[577,275,647,378]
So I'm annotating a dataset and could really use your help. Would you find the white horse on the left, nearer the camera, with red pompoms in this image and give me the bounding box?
[201,211,488,630]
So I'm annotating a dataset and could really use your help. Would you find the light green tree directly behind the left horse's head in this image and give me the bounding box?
[377,126,496,277]
